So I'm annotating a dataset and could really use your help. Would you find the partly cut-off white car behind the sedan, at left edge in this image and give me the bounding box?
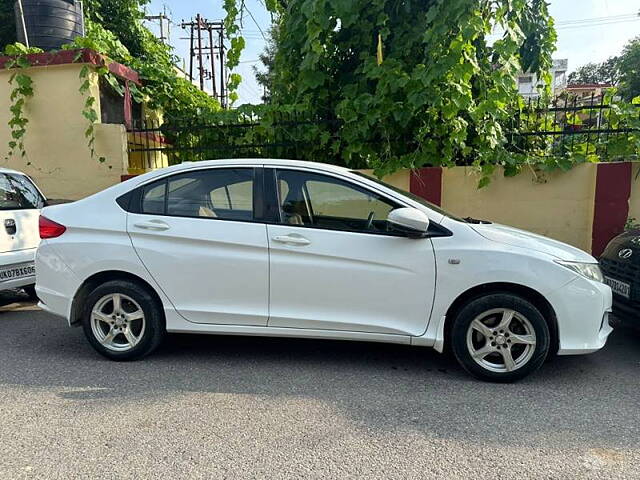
[0,168,46,296]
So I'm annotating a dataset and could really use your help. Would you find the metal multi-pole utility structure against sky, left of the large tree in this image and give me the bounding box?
[180,14,228,107]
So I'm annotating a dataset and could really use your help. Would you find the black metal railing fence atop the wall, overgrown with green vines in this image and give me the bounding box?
[128,95,640,169]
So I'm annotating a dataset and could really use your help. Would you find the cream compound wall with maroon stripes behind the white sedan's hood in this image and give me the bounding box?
[396,162,640,256]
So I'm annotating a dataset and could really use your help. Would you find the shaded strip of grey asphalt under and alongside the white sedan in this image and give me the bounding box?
[0,312,640,448]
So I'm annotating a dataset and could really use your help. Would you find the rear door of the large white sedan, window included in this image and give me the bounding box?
[127,167,269,326]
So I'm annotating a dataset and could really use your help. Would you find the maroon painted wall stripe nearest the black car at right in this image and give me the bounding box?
[591,162,631,257]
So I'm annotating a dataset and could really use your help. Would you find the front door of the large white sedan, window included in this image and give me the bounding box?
[266,168,435,335]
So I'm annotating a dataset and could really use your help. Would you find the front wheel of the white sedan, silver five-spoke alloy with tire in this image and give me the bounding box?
[451,293,550,382]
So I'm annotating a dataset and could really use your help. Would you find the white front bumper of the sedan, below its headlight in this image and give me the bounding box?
[547,277,613,355]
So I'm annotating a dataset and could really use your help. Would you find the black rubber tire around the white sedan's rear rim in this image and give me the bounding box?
[82,280,166,361]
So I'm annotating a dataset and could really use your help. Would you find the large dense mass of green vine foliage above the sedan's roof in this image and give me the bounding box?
[225,0,555,178]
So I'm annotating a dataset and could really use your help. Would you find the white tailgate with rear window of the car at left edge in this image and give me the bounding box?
[0,173,45,253]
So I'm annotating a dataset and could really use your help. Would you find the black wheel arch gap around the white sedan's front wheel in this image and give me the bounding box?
[444,282,560,355]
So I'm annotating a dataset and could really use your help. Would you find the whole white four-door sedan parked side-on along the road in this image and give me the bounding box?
[36,160,612,381]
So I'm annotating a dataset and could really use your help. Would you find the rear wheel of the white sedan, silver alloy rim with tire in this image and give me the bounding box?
[82,280,166,360]
